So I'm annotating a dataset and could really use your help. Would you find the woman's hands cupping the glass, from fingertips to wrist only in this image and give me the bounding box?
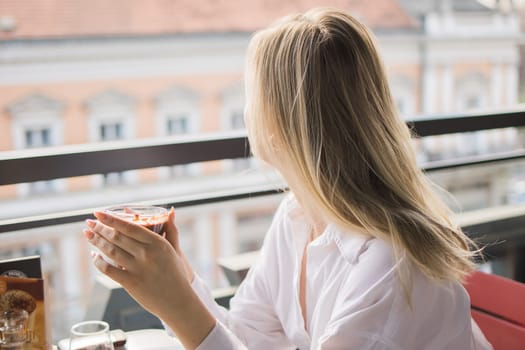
[84,210,193,314]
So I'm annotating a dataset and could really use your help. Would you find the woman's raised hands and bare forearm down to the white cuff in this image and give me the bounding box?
[84,210,216,349]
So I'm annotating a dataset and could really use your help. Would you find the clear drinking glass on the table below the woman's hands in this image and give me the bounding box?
[69,321,114,350]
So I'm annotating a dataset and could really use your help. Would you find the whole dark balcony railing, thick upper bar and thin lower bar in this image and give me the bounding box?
[0,110,525,237]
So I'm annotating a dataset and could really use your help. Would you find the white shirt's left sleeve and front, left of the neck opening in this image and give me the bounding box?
[168,198,294,350]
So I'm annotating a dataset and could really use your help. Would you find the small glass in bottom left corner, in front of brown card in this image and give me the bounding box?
[0,309,29,349]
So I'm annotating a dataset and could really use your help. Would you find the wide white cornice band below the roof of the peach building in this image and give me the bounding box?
[0,29,519,86]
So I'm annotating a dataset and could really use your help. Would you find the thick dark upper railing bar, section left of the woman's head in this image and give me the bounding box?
[0,132,250,185]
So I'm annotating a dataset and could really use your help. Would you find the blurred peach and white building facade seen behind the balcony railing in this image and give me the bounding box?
[0,0,520,340]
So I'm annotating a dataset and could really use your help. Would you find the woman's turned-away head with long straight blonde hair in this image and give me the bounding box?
[246,9,475,281]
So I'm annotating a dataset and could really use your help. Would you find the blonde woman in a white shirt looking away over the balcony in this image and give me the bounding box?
[84,9,490,350]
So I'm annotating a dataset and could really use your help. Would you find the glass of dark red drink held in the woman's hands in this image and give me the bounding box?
[105,204,168,234]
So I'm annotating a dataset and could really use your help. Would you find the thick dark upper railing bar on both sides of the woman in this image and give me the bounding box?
[0,111,525,186]
